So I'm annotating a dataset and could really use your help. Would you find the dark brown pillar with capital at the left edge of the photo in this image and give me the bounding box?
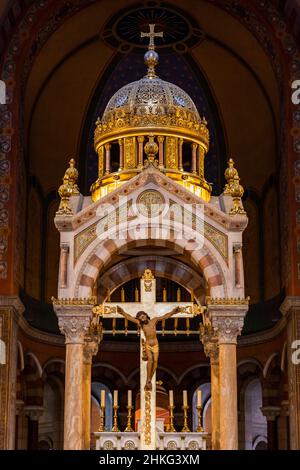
[0,296,24,450]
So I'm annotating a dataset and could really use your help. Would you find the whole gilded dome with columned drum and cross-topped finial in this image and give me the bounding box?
[91,25,211,200]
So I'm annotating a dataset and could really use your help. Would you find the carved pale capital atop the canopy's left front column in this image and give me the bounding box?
[52,297,96,344]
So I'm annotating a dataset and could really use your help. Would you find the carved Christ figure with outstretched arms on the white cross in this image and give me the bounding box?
[117,305,180,390]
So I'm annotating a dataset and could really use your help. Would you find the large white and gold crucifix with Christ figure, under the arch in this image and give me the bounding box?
[96,269,202,450]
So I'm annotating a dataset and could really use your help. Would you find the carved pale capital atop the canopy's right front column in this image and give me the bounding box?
[207,298,249,344]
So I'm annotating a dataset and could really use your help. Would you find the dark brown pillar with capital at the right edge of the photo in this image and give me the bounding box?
[280,297,300,450]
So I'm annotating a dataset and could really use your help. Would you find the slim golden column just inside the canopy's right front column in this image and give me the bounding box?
[201,326,220,450]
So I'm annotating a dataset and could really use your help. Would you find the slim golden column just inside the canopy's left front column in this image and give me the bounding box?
[82,336,98,450]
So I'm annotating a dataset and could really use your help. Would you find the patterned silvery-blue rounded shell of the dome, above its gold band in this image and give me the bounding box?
[102,76,200,122]
